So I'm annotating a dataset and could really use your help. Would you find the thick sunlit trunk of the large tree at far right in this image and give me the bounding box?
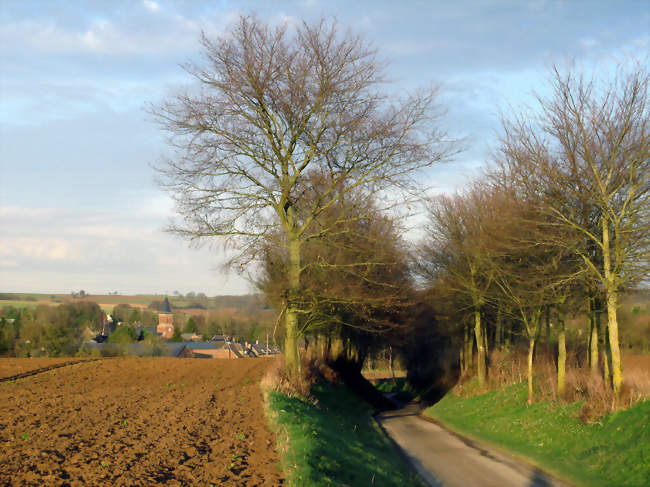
[603,223,623,401]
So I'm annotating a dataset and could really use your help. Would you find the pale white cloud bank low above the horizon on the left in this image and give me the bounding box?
[0,205,251,295]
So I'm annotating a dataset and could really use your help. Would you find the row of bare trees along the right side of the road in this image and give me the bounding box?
[418,68,650,400]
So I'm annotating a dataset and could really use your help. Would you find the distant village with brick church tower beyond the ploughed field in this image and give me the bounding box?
[82,298,280,359]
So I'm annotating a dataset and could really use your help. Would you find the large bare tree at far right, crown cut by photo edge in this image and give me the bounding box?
[494,67,650,397]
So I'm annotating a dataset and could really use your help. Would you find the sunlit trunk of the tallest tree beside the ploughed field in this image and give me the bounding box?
[284,239,300,377]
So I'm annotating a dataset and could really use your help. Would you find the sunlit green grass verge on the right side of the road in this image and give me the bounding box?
[424,383,650,486]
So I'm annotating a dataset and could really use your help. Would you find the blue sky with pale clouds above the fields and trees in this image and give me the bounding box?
[0,0,650,295]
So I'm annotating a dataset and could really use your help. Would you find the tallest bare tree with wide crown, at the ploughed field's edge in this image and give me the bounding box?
[152,17,451,371]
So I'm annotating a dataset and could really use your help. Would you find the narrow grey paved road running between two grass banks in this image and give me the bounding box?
[377,404,568,487]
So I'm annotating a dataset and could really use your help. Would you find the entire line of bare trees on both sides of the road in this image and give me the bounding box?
[151,17,650,404]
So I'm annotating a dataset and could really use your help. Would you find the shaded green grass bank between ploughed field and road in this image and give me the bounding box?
[266,383,425,487]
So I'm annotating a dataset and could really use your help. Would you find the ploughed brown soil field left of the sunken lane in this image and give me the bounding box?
[0,358,283,486]
